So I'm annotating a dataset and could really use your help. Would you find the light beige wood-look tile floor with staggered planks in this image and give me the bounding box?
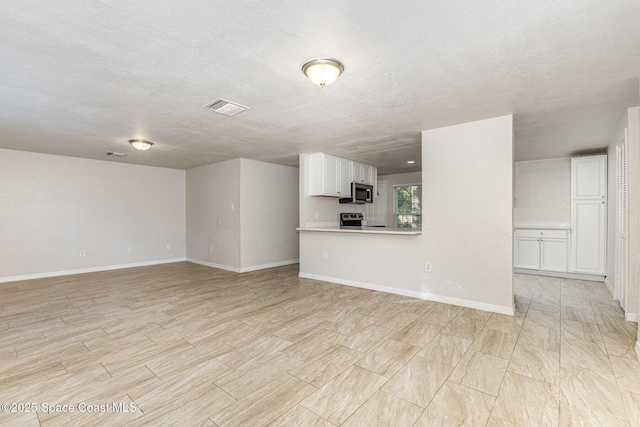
[0,263,640,427]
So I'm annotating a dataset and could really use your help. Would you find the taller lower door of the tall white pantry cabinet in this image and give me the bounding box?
[571,199,607,275]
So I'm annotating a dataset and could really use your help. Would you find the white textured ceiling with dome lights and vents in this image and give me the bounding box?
[0,0,640,174]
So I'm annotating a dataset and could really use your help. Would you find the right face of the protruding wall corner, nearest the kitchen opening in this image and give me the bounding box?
[240,159,300,271]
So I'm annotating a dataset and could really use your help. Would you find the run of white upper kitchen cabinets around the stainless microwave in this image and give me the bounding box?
[309,153,378,197]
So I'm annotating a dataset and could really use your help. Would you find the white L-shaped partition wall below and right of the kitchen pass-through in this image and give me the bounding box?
[300,116,513,313]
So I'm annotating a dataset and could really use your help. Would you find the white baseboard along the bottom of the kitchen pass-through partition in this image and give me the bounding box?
[298,272,515,316]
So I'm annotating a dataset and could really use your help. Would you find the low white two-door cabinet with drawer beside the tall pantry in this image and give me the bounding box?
[513,228,569,272]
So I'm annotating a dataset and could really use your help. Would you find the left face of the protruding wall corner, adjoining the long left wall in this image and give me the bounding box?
[186,159,241,270]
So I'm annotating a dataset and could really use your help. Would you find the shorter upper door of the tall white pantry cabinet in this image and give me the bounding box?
[571,156,607,200]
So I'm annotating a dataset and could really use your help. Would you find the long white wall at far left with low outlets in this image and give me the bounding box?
[0,149,185,281]
